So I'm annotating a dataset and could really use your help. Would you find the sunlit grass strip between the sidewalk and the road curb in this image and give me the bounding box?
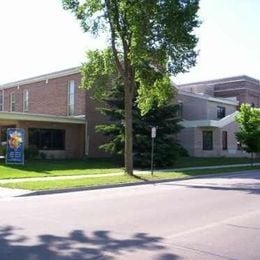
[0,166,260,191]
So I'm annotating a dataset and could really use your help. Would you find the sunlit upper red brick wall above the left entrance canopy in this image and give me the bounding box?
[4,73,85,116]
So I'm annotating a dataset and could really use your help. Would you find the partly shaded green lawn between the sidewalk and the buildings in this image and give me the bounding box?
[0,157,260,179]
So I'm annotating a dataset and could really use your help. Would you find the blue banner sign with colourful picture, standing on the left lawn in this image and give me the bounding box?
[6,128,24,164]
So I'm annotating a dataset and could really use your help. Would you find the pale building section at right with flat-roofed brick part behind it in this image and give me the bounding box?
[177,76,260,157]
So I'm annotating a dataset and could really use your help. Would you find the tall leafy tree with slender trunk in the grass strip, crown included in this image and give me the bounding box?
[63,0,199,174]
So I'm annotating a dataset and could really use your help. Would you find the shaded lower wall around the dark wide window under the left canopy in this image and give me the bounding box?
[17,121,85,159]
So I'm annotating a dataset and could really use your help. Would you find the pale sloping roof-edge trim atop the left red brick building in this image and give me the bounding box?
[0,67,80,89]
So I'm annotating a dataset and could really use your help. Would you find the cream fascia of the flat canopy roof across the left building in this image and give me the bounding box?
[0,112,86,124]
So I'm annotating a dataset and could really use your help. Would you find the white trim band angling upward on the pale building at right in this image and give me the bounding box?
[181,111,239,128]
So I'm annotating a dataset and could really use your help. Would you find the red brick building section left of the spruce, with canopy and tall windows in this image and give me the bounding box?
[0,68,106,158]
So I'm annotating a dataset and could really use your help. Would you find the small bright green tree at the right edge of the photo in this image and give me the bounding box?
[236,104,260,163]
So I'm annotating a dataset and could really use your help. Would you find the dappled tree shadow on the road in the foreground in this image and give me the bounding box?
[0,226,180,260]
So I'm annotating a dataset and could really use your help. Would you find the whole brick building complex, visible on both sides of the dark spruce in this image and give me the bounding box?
[0,68,260,158]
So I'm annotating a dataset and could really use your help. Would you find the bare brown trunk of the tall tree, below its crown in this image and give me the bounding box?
[124,82,133,175]
